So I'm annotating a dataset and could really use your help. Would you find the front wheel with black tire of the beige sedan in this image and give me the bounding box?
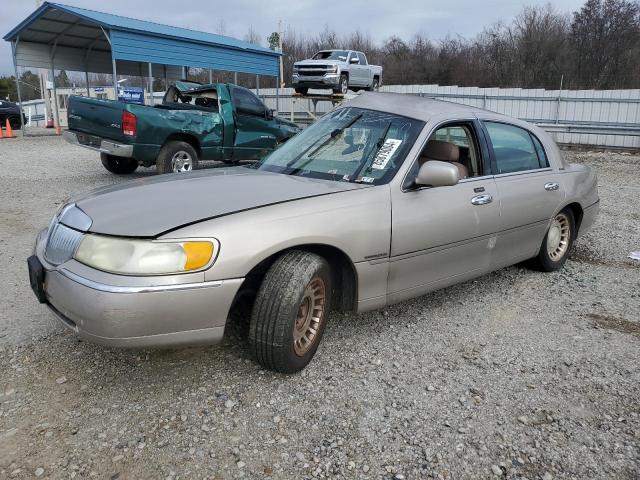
[249,250,332,373]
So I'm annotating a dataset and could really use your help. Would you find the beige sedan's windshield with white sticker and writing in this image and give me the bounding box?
[252,107,424,185]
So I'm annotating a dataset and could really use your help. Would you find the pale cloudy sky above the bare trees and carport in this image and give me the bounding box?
[0,0,585,75]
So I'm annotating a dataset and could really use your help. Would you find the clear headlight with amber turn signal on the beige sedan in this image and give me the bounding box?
[74,234,218,275]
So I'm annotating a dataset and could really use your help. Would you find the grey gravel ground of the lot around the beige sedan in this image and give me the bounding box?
[0,138,640,480]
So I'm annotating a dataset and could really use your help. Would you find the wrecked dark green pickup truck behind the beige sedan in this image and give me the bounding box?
[64,81,300,174]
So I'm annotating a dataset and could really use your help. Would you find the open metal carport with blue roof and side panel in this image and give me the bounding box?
[4,2,280,131]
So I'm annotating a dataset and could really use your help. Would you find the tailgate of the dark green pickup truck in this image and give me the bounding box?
[68,96,125,140]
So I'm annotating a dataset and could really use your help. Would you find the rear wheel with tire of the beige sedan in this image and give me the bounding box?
[529,208,576,272]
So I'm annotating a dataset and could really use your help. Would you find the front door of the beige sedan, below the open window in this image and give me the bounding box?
[388,120,500,302]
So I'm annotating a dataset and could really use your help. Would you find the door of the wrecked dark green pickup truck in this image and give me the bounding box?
[231,86,277,160]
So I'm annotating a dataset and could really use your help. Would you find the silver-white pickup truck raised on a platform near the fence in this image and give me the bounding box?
[292,50,382,95]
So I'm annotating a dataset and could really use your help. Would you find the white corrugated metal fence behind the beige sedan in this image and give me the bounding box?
[260,85,640,149]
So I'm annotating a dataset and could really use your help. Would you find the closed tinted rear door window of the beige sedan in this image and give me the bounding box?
[484,122,548,174]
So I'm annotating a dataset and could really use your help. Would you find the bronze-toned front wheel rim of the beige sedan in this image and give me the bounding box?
[293,277,326,357]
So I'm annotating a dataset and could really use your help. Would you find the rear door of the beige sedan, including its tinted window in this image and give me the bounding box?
[483,117,565,268]
